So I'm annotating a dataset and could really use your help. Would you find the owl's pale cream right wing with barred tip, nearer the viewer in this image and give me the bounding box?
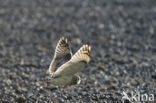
[54,45,91,78]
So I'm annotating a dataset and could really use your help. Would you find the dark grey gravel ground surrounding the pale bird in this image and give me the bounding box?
[0,0,156,103]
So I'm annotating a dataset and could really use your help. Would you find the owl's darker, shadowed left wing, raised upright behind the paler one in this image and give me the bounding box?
[49,37,72,75]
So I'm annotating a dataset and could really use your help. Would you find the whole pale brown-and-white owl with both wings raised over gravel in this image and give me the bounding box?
[49,39,91,85]
